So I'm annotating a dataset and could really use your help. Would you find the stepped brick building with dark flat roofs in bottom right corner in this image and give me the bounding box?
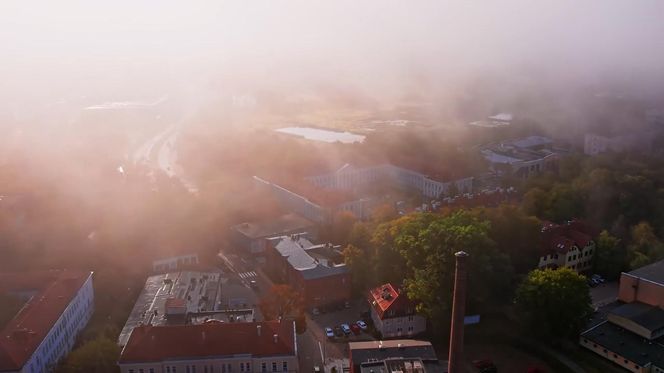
[579,261,664,373]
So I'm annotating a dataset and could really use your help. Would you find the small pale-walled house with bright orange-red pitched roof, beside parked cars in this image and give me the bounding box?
[368,283,427,338]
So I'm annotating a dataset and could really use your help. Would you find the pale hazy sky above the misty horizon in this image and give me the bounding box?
[0,0,664,104]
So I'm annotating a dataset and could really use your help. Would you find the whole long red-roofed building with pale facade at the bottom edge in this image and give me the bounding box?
[118,321,299,373]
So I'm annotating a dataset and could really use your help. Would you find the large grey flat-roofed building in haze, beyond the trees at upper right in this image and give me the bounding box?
[481,136,561,179]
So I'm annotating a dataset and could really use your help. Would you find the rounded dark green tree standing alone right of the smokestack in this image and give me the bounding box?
[516,268,592,339]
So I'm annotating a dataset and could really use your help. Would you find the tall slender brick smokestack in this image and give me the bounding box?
[447,251,468,373]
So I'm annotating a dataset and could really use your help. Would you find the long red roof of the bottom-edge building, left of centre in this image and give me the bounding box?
[119,321,295,364]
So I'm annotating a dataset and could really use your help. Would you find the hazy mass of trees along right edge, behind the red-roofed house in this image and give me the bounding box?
[522,153,664,278]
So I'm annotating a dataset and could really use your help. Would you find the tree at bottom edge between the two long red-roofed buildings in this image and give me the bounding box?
[57,336,120,373]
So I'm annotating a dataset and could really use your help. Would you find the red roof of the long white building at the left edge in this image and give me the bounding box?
[0,270,92,371]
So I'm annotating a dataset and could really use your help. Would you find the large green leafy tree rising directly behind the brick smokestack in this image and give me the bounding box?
[382,211,512,334]
